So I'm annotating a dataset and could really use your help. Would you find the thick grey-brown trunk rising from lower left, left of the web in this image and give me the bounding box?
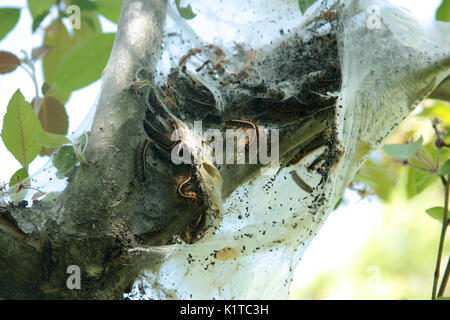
[0,0,167,299]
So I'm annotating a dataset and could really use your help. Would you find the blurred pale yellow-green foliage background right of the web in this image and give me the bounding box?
[291,100,450,299]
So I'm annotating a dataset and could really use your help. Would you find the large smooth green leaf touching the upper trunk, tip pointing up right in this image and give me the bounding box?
[55,33,115,91]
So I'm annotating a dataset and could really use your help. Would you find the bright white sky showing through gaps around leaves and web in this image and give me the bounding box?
[0,0,441,298]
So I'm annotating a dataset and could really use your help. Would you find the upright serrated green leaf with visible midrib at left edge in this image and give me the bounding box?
[2,90,42,168]
